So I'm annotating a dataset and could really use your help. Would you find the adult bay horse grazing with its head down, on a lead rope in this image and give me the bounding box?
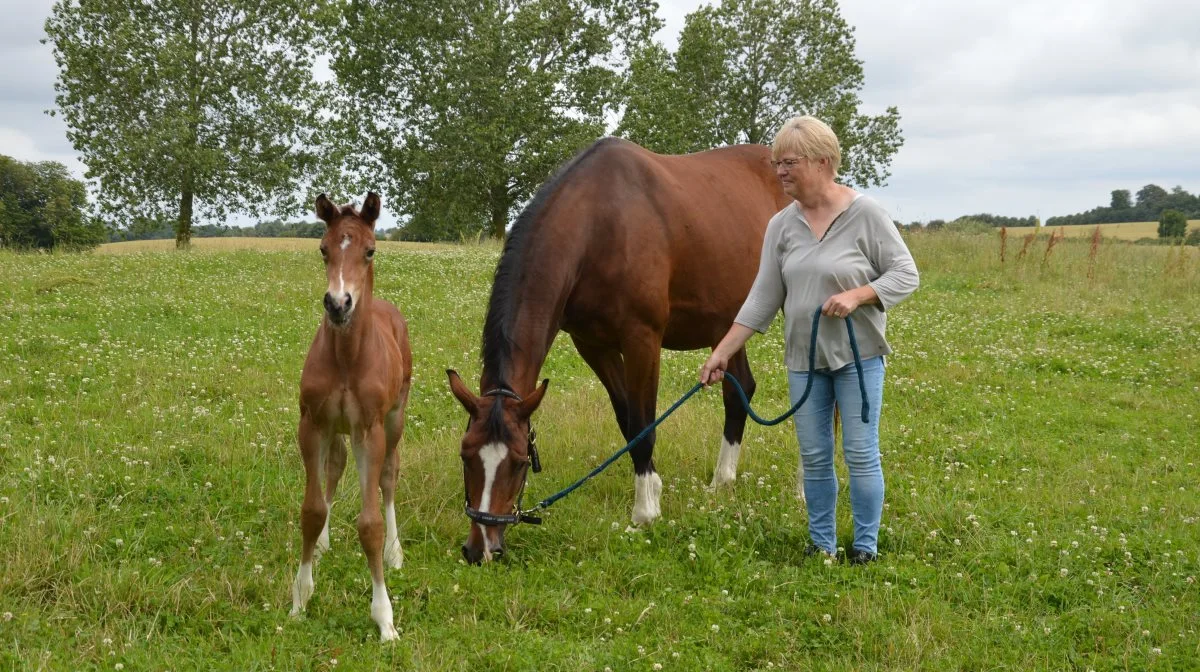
[446,138,791,563]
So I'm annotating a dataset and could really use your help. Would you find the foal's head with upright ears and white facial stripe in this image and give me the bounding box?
[317,192,379,326]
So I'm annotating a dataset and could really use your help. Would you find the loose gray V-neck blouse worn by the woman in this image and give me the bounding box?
[734,194,919,371]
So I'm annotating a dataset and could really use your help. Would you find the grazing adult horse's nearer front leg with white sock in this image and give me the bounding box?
[624,340,662,526]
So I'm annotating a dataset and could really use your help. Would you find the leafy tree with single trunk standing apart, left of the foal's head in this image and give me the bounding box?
[46,0,320,247]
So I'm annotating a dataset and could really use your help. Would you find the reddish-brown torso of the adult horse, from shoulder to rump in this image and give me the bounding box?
[562,140,787,349]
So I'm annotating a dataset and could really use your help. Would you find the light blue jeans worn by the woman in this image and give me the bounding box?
[787,356,884,553]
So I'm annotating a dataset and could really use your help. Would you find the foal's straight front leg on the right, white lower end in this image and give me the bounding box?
[353,418,400,642]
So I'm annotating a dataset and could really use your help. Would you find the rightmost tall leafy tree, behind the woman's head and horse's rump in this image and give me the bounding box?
[617,0,904,186]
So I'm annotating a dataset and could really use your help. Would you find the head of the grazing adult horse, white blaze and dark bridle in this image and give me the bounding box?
[446,370,550,564]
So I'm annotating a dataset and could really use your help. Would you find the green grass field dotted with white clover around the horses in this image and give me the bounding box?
[0,234,1200,671]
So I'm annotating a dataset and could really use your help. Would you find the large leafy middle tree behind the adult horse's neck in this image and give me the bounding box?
[332,0,660,240]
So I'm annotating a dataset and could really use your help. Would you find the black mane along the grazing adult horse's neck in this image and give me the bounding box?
[479,138,620,388]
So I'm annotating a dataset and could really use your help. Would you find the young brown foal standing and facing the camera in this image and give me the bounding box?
[292,192,413,642]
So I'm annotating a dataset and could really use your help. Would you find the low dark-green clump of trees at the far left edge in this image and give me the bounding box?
[0,156,106,250]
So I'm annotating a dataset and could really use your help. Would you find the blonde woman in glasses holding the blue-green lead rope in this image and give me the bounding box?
[700,116,918,564]
